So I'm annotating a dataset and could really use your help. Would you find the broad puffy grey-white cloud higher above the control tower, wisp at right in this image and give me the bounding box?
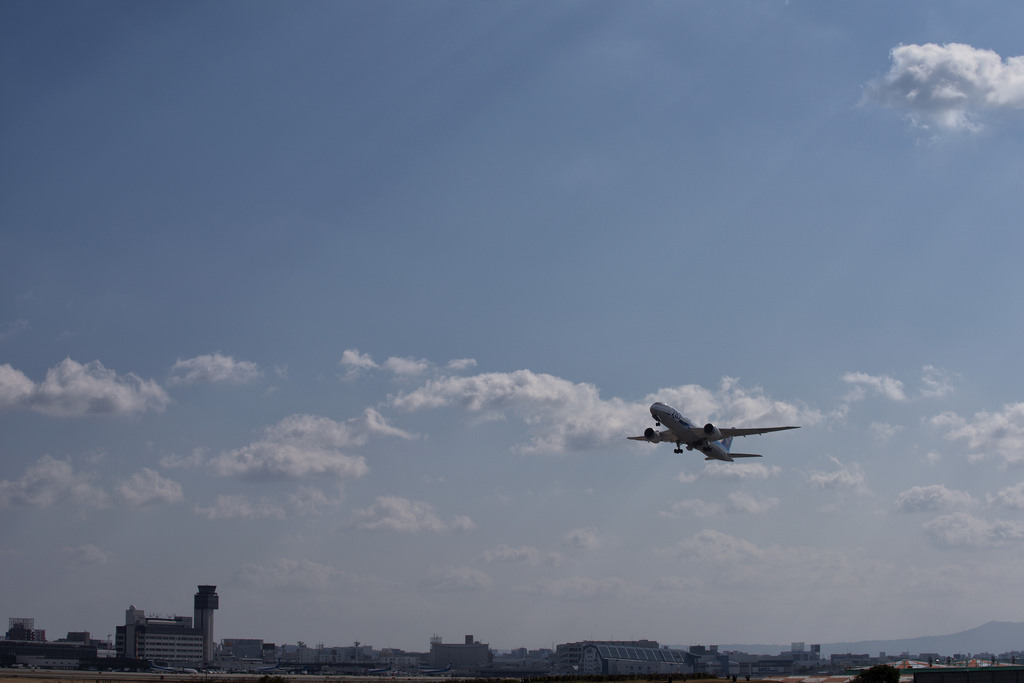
[212,415,370,479]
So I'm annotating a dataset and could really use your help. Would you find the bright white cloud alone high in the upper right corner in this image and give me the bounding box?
[864,43,1024,130]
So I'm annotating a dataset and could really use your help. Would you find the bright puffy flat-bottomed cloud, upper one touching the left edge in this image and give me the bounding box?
[0,358,171,417]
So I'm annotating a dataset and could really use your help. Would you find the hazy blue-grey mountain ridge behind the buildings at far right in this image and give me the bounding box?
[719,622,1024,657]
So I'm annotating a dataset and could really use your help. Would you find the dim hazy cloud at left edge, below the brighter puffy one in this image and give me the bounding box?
[0,456,108,508]
